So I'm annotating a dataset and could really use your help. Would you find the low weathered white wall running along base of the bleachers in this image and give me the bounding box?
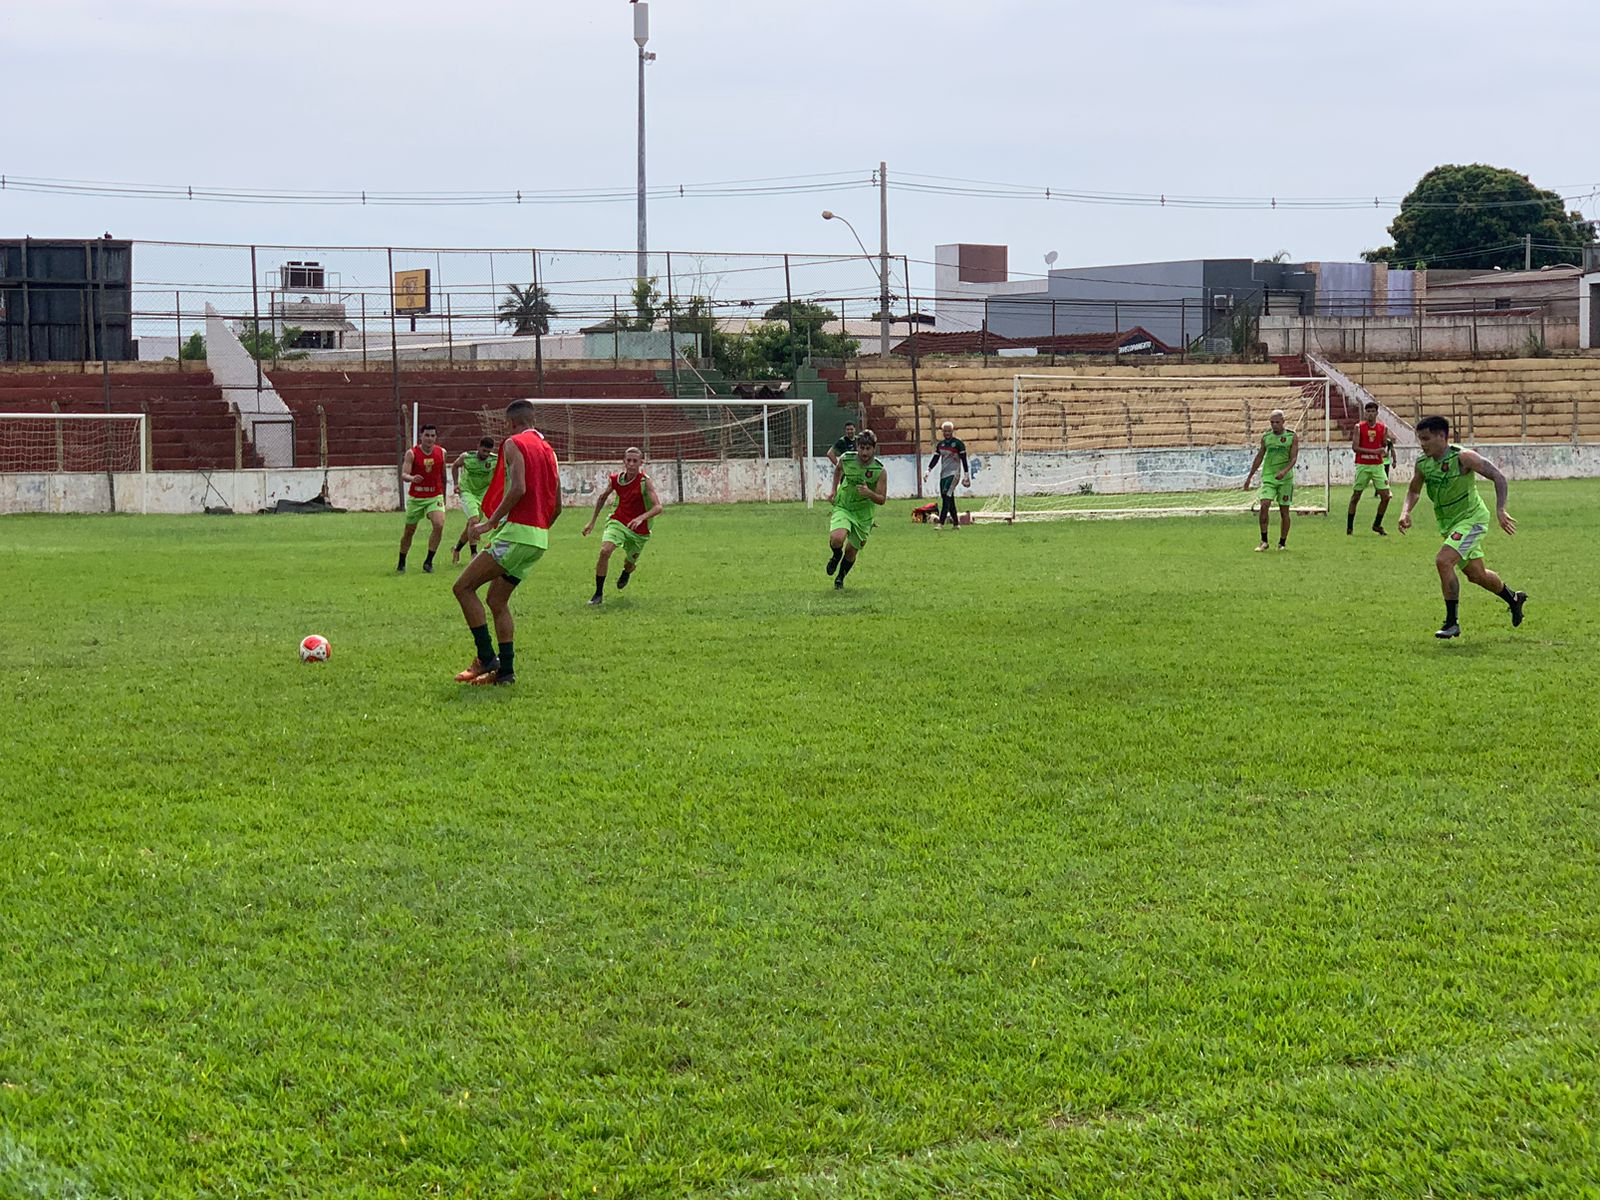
[0,442,1600,514]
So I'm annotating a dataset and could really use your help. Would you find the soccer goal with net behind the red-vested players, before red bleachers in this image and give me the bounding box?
[413,397,816,504]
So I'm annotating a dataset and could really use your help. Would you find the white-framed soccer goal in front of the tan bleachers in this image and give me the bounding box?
[973,374,1333,522]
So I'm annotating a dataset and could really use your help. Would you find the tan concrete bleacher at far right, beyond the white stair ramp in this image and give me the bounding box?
[1338,355,1600,445]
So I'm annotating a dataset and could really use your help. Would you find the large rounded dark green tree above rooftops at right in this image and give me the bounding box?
[1362,163,1594,270]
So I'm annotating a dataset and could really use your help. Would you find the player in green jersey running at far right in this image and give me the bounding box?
[1400,416,1528,638]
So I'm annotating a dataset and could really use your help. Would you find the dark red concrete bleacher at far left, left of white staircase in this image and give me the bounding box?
[0,363,261,470]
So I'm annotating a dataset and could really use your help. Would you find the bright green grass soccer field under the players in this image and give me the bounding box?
[0,483,1600,1198]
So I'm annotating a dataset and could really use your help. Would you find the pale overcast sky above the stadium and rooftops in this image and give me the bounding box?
[0,0,1600,299]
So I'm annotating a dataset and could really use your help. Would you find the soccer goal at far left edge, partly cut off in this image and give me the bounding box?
[0,413,150,512]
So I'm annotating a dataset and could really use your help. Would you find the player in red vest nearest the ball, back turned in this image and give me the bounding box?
[453,400,562,685]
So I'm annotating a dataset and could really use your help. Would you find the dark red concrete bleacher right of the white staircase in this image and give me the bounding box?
[269,363,722,467]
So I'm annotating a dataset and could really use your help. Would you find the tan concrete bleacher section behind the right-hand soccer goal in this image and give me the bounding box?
[824,362,1318,453]
